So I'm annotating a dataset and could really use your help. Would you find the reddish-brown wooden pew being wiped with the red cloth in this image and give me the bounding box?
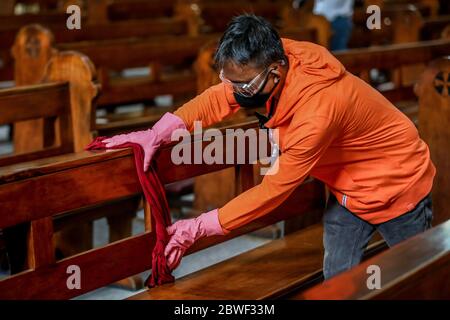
[0,47,448,299]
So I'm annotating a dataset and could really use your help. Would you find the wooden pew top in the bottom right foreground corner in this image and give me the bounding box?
[283,220,450,300]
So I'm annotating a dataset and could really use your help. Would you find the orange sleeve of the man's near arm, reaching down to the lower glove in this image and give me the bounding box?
[219,116,336,233]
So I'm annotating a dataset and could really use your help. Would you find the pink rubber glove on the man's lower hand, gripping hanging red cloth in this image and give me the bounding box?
[164,209,225,270]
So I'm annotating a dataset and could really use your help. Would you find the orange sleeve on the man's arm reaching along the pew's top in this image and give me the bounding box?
[174,83,239,131]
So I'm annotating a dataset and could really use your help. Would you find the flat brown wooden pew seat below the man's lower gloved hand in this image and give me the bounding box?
[128,223,384,300]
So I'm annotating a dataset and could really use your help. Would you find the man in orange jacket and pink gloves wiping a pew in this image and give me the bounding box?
[106,15,435,278]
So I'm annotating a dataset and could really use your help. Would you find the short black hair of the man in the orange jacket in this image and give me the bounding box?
[214,14,284,70]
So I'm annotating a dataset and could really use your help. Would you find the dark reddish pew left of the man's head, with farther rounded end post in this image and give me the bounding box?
[7,25,214,152]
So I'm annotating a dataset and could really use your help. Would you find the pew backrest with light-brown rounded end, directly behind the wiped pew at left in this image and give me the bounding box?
[0,46,98,165]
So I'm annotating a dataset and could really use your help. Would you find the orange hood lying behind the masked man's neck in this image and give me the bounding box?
[266,39,345,128]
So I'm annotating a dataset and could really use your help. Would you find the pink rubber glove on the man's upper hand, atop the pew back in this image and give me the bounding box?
[104,112,186,172]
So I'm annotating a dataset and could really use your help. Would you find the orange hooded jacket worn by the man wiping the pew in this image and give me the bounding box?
[175,39,436,233]
